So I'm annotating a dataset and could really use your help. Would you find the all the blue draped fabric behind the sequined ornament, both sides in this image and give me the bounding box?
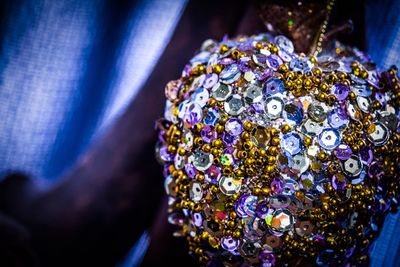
[0,0,400,266]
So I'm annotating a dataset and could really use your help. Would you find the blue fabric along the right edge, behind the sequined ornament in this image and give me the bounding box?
[365,0,400,267]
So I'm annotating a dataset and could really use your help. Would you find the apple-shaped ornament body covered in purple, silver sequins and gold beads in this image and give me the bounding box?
[157,34,400,266]
